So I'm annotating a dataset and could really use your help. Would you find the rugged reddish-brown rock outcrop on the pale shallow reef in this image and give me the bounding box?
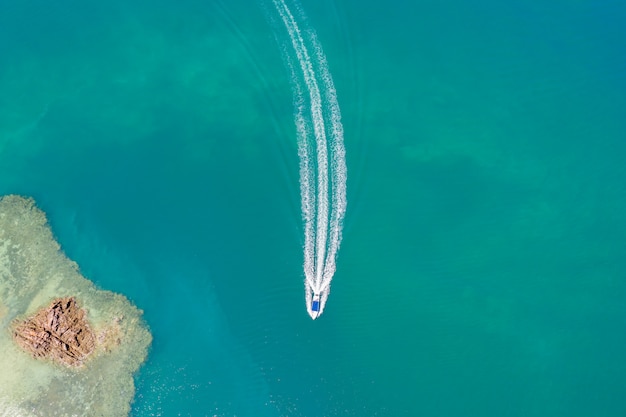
[13,297,96,367]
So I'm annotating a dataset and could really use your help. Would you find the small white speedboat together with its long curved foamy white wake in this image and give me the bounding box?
[273,0,347,319]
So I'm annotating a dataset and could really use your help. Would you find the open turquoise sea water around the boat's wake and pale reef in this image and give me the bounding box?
[0,0,626,417]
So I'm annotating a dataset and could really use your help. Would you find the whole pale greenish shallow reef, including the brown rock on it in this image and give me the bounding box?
[0,196,152,417]
